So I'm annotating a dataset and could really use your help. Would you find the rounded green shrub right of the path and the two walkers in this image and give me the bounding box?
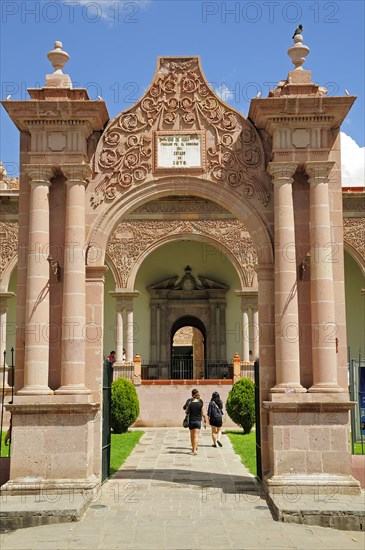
[226,378,255,434]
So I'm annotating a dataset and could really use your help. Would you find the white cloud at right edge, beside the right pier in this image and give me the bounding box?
[341,132,365,187]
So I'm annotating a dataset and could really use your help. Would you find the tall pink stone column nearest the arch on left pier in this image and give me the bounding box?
[56,164,90,394]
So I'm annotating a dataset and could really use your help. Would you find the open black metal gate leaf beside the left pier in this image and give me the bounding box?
[101,360,113,482]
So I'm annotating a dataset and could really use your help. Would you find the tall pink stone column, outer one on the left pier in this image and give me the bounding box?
[18,164,54,395]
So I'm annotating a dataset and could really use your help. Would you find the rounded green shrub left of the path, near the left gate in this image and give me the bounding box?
[111,378,139,434]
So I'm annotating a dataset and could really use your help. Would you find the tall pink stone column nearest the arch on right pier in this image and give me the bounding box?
[269,162,306,392]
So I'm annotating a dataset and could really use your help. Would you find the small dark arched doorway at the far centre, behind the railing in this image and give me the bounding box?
[171,315,206,380]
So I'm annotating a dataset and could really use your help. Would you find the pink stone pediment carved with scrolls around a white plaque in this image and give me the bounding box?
[91,57,271,207]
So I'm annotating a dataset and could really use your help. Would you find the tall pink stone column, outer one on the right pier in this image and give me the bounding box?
[305,161,344,392]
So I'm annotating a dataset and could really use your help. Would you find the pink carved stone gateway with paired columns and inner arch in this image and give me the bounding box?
[0,40,364,508]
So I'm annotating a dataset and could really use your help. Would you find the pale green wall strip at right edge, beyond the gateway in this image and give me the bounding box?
[345,252,365,359]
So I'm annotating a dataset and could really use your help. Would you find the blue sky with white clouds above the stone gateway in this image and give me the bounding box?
[0,0,365,185]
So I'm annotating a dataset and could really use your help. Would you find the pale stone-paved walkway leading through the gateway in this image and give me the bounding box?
[0,428,365,550]
